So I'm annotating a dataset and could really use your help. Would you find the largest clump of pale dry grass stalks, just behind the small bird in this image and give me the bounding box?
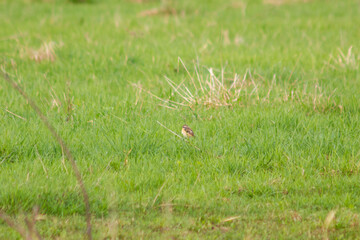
[135,58,258,109]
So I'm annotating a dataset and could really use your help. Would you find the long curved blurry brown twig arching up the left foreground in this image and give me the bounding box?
[0,71,92,240]
